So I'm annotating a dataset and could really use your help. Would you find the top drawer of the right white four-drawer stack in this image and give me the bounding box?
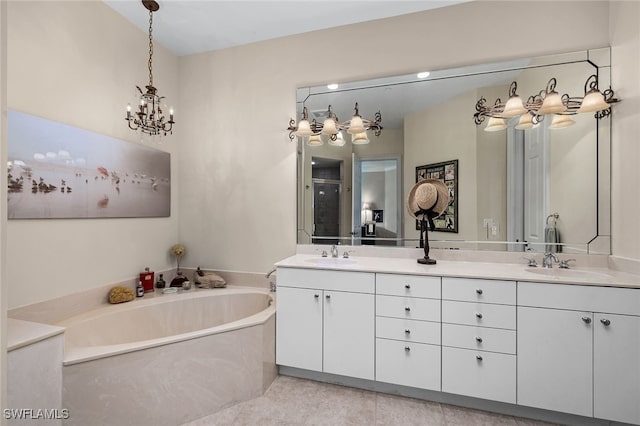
[442,277,516,305]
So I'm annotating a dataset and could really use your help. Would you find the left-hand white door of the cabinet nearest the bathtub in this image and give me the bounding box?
[276,287,322,371]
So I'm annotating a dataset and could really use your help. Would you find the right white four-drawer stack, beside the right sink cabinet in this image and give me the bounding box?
[442,277,516,403]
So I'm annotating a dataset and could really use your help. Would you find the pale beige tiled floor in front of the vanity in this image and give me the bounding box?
[183,376,551,426]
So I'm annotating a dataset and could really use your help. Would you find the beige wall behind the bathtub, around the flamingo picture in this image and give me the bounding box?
[2,1,180,308]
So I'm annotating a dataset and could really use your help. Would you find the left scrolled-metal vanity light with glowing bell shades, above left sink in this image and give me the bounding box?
[287,102,382,146]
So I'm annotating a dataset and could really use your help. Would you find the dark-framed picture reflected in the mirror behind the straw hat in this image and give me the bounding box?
[416,160,458,234]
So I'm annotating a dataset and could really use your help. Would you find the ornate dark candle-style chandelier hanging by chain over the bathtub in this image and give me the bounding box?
[126,0,175,136]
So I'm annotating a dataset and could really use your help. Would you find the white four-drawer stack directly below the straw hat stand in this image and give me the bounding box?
[376,274,441,391]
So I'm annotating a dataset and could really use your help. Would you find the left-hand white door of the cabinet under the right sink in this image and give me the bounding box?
[517,307,593,416]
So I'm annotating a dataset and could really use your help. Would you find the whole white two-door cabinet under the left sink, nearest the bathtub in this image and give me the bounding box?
[276,268,375,380]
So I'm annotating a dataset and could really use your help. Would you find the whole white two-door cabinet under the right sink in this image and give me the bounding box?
[517,283,640,424]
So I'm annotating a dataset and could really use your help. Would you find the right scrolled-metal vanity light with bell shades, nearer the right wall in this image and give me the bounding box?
[473,74,619,132]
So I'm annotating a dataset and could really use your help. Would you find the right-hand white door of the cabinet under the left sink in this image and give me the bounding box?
[324,290,375,380]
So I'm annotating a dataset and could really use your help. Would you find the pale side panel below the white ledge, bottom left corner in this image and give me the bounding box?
[7,334,64,426]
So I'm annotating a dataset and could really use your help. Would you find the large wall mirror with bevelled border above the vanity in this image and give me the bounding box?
[297,48,610,254]
